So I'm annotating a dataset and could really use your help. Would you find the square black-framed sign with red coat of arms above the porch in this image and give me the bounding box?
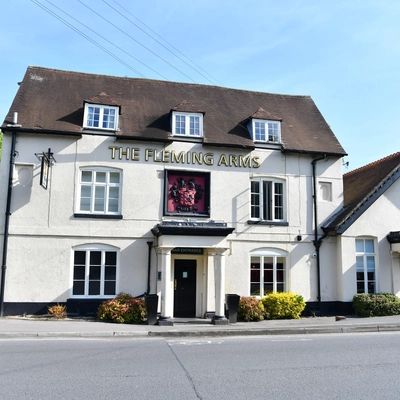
[165,170,210,217]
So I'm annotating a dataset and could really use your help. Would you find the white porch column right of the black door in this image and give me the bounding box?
[211,249,228,325]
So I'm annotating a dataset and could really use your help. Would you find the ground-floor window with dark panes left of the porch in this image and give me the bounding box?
[72,244,118,297]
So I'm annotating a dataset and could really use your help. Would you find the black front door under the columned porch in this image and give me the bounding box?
[174,260,196,318]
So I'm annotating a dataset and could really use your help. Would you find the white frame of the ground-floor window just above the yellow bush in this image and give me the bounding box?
[249,249,288,298]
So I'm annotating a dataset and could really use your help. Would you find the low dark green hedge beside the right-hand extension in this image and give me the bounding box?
[353,293,400,317]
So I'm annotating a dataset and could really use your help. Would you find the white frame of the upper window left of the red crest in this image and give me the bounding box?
[77,167,122,215]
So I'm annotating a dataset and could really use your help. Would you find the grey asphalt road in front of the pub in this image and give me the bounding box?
[0,332,400,400]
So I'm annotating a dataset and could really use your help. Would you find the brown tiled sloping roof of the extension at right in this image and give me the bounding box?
[324,152,400,234]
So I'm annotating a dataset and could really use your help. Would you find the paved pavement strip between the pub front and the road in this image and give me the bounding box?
[0,315,400,339]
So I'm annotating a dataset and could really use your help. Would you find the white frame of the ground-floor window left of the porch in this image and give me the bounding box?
[70,244,120,299]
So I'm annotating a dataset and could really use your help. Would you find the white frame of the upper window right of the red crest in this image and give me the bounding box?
[250,177,287,222]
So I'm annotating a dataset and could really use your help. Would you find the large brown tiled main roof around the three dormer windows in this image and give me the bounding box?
[1,67,346,156]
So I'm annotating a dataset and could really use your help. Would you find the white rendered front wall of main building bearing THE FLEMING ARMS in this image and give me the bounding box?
[0,130,342,304]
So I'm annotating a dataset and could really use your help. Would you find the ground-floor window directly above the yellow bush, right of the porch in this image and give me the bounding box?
[250,250,286,297]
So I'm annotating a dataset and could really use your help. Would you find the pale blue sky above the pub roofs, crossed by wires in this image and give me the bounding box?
[0,0,400,172]
